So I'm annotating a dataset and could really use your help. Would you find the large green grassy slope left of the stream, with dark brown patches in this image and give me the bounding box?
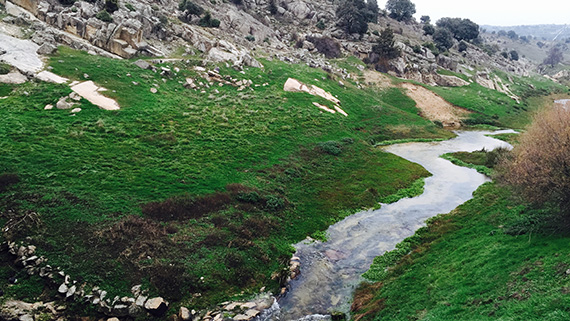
[0,48,444,307]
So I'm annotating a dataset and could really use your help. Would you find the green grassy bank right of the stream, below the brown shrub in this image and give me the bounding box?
[353,183,570,320]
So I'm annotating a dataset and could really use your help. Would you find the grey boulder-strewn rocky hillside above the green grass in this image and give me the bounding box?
[0,0,535,88]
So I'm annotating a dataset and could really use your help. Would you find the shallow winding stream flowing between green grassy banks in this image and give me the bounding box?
[260,130,514,321]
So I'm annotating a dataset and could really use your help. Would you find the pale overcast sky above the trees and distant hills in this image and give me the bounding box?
[378,0,570,26]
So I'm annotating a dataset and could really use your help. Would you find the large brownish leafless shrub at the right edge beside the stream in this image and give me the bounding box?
[499,107,570,216]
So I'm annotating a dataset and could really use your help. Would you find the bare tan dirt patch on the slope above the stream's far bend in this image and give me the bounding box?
[401,83,470,127]
